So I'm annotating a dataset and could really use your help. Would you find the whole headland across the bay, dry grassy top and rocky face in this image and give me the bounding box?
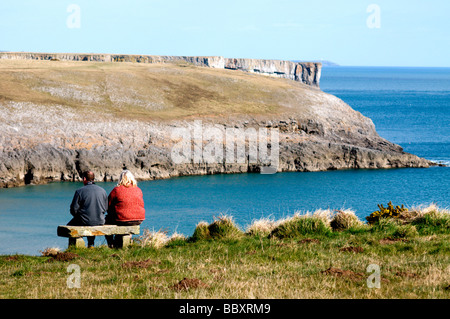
[0,55,431,187]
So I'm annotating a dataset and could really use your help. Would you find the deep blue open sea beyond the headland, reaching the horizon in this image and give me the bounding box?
[321,67,450,163]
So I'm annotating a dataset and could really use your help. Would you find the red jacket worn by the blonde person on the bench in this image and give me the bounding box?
[108,185,145,221]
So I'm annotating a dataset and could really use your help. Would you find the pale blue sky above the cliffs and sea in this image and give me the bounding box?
[0,0,450,67]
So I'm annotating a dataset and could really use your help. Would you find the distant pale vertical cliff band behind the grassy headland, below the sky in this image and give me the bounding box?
[0,52,322,87]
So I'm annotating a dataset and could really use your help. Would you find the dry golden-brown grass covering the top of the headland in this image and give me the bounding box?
[0,60,318,121]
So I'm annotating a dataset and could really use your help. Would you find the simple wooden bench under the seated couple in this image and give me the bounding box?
[57,225,140,248]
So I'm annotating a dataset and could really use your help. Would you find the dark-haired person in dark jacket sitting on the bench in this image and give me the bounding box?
[67,171,108,247]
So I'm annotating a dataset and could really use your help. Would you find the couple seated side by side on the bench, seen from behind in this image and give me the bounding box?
[67,170,145,248]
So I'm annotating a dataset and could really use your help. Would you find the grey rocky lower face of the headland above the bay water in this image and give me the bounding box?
[0,104,430,187]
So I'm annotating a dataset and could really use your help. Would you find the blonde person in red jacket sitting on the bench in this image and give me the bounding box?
[105,170,145,247]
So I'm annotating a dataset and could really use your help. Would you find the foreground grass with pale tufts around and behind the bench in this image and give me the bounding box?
[0,205,450,299]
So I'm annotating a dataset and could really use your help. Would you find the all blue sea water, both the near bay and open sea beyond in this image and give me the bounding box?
[0,67,450,255]
